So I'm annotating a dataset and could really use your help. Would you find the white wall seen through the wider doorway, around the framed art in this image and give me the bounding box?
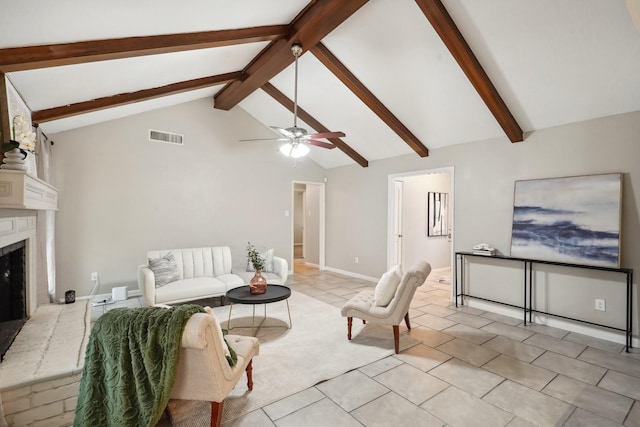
[402,172,452,270]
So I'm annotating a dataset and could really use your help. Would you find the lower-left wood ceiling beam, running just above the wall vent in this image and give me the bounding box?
[31,71,242,124]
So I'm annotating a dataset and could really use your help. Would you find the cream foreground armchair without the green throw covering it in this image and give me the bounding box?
[170,307,260,426]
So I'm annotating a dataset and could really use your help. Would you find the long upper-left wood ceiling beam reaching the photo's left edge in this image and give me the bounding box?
[0,25,290,73]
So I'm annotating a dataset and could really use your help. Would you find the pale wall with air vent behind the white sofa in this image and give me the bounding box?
[51,99,324,297]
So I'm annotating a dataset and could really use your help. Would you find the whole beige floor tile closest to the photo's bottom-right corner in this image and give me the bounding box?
[542,375,633,423]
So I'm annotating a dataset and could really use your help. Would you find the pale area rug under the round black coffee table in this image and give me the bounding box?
[162,291,420,427]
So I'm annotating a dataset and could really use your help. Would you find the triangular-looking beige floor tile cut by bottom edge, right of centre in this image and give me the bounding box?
[350,393,444,427]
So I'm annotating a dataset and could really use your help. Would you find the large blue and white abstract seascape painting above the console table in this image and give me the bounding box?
[511,174,622,268]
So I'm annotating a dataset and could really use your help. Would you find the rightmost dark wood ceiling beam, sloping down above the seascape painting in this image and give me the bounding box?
[415,0,524,142]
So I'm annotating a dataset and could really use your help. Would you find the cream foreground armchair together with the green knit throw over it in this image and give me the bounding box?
[74,305,259,427]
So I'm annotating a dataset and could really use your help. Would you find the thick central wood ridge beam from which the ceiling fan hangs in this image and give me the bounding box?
[214,0,368,110]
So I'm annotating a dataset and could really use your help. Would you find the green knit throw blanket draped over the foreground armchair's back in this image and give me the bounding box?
[73,305,204,427]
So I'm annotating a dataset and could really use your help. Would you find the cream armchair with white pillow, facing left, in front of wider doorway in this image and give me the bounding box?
[342,262,431,353]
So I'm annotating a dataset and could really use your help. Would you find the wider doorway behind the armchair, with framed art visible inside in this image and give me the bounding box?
[387,167,455,269]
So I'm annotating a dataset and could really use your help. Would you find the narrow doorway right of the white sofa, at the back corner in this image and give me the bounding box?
[290,182,324,271]
